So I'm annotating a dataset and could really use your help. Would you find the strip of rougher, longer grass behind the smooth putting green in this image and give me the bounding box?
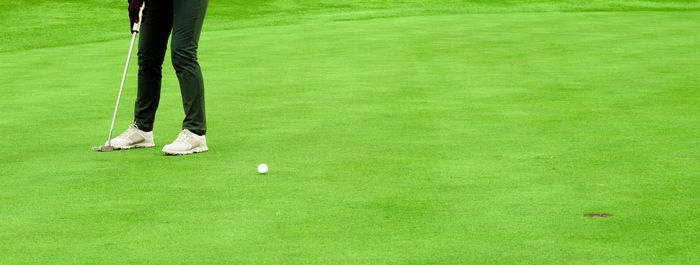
[0,0,700,52]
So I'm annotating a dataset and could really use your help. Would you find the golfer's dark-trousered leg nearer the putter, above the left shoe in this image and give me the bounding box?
[134,1,173,131]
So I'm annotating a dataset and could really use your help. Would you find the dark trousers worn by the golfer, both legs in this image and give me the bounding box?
[134,0,209,135]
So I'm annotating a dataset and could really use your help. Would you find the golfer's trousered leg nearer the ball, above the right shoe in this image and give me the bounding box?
[170,0,209,135]
